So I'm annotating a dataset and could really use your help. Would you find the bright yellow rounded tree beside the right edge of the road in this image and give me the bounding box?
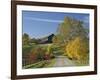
[65,37,89,60]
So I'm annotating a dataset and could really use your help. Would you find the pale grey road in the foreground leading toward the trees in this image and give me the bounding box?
[53,56,76,67]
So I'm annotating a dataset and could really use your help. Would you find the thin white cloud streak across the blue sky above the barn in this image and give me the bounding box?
[25,17,63,23]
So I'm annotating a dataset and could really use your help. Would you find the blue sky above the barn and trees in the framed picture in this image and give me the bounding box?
[22,11,89,38]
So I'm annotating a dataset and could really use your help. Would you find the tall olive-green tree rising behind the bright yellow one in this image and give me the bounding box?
[53,17,87,44]
